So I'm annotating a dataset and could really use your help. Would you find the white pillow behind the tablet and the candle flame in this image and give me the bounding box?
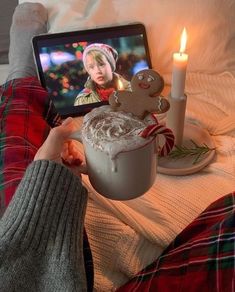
[20,0,235,74]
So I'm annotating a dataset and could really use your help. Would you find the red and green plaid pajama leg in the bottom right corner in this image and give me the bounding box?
[117,193,235,292]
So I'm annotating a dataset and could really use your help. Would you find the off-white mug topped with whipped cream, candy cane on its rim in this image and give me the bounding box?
[71,106,174,200]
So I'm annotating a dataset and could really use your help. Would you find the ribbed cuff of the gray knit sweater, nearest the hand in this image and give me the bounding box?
[0,160,87,252]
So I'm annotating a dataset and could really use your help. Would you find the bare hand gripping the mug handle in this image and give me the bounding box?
[34,118,85,175]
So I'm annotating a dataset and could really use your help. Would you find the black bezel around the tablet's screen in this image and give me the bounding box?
[32,23,152,118]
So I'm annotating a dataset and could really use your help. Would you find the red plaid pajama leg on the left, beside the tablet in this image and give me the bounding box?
[0,77,93,291]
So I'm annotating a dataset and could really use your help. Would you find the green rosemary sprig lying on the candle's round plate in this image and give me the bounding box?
[169,140,215,164]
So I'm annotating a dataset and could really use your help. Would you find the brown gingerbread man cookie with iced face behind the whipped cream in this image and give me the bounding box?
[109,69,170,119]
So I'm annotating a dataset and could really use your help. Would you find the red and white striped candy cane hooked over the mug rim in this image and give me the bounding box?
[140,124,175,156]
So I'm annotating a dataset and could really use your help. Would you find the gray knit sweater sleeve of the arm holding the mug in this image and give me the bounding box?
[0,160,87,292]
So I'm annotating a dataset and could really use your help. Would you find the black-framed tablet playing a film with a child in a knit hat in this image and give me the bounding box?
[32,23,152,117]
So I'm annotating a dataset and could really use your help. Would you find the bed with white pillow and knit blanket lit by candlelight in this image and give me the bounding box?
[0,0,235,291]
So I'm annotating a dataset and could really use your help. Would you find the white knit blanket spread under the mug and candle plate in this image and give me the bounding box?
[84,72,235,291]
